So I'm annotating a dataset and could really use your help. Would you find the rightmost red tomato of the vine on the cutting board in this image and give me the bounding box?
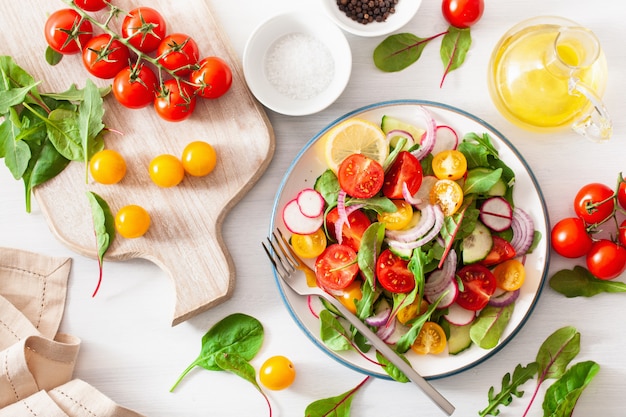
[190,56,233,98]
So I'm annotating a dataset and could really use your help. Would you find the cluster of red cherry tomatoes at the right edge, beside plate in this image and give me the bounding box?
[551,174,626,280]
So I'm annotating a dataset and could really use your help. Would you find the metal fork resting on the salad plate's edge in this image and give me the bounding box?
[261,229,454,416]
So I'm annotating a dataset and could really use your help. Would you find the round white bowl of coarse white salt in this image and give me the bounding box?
[243,12,352,116]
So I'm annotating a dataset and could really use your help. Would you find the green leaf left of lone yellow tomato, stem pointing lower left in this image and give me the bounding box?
[170,313,264,392]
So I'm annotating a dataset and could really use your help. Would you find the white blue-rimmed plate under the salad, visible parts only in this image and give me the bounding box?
[270,100,550,379]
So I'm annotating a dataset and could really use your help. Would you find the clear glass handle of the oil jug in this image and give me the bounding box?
[568,77,613,142]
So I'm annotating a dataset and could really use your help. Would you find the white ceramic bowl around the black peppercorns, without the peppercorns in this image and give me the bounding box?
[320,0,422,37]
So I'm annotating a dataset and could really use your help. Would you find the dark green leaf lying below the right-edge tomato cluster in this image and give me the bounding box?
[550,265,626,298]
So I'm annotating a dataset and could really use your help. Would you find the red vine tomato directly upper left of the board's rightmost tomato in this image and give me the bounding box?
[157,33,200,75]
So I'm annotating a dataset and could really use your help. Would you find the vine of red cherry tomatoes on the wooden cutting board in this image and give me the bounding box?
[45,0,232,122]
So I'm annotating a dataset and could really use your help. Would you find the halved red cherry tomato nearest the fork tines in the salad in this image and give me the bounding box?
[315,243,359,291]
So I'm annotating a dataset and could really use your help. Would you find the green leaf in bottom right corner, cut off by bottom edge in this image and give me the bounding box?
[543,361,600,417]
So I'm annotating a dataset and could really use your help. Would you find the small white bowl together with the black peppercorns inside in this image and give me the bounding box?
[320,0,422,37]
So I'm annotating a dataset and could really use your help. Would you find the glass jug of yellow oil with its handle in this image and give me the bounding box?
[488,16,612,141]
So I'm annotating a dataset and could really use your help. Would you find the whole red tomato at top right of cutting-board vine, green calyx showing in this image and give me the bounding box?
[122,7,167,54]
